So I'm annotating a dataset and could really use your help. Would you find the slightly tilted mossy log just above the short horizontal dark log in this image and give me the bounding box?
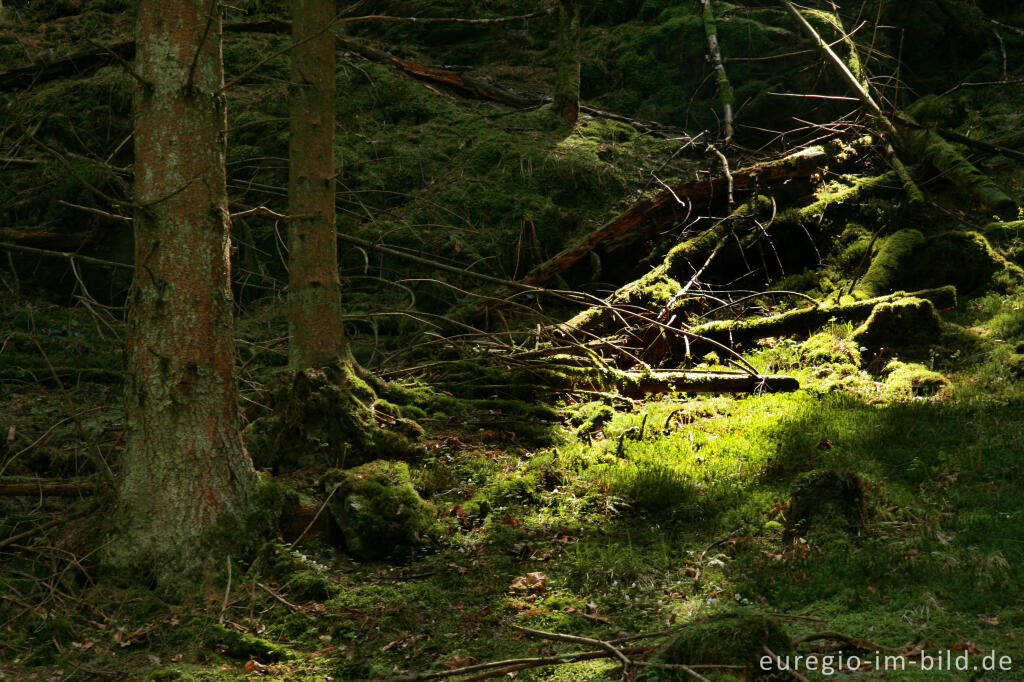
[690,287,956,345]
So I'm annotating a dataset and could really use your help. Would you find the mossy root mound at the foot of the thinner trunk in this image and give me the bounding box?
[243,363,423,473]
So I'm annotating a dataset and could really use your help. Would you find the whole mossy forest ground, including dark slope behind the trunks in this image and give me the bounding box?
[0,0,1024,682]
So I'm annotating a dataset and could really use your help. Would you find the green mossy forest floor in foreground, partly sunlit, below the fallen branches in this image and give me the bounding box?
[6,282,1024,680]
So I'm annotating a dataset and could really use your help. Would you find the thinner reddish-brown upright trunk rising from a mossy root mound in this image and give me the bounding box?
[288,0,344,370]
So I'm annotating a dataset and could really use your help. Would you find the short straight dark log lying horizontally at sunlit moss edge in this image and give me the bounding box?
[618,372,800,397]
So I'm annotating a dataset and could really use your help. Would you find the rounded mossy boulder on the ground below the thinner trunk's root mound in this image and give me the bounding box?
[322,460,436,559]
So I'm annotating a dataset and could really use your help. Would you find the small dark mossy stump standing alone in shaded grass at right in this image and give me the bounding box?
[782,471,867,545]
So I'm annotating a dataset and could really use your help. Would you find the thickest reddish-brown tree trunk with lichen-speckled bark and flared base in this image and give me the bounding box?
[108,0,256,589]
